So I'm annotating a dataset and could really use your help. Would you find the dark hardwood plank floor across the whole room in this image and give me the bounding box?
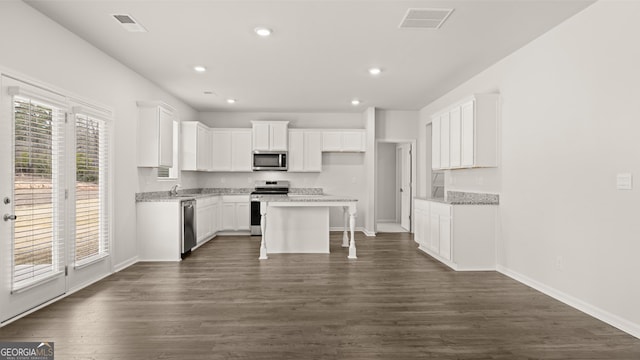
[0,233,640,360]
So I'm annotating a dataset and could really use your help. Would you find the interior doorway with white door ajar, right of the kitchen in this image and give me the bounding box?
[376,141,416,232]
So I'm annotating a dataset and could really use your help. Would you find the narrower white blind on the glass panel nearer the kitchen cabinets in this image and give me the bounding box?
[74,108,110,266]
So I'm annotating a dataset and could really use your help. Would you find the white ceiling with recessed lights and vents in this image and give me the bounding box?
[25,0,593,112]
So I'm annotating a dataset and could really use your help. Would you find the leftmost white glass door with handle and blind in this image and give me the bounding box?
[0,77,69,321]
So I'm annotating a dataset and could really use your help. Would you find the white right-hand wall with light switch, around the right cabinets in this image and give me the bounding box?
[420,1,640,336]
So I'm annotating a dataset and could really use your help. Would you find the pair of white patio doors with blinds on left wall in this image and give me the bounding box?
[0,76,112,322]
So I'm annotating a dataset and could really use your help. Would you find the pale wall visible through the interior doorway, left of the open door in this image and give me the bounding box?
[376,143,398,222]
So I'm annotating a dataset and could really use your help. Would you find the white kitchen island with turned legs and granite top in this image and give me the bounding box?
[258,195,357,260]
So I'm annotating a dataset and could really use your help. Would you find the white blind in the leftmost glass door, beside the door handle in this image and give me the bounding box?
[12,94,66,291]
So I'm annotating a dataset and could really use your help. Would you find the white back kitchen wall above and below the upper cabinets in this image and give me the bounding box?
[197,112,370,227]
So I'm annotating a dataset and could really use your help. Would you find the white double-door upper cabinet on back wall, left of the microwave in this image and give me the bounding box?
[210,128,251,172]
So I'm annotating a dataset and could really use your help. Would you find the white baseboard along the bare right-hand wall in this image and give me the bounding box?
[496,265,640,339]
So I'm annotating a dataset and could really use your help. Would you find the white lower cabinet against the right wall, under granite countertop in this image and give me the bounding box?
[414,199,496,270]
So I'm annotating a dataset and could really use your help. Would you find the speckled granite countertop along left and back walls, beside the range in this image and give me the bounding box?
[136,188,322,202]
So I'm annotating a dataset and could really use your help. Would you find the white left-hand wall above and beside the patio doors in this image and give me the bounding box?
[0,1,195,266]
